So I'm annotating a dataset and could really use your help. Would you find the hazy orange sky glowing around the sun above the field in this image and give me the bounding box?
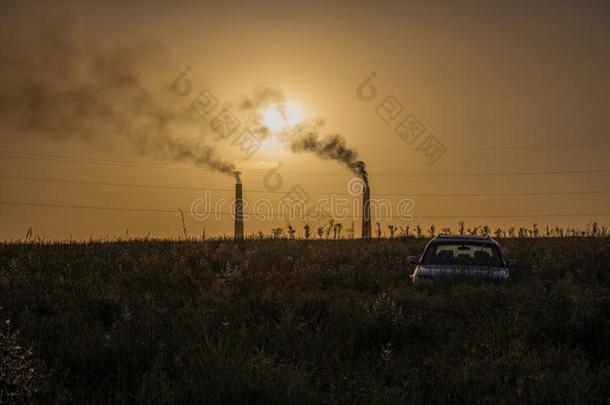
[0,1,610,239]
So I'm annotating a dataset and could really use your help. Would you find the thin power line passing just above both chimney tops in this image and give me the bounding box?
[0,150,610,177]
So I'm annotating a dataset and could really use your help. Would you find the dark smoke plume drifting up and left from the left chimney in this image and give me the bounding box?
[0,15,235,174]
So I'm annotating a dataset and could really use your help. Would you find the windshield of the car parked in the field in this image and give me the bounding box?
[422,242,503,267]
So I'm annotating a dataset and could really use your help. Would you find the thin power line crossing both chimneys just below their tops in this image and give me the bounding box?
[0,175,610,198]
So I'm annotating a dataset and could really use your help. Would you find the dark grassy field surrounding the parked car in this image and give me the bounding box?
[0,237,610,403]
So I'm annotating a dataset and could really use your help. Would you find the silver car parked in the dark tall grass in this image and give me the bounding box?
[409,235,517,285]
